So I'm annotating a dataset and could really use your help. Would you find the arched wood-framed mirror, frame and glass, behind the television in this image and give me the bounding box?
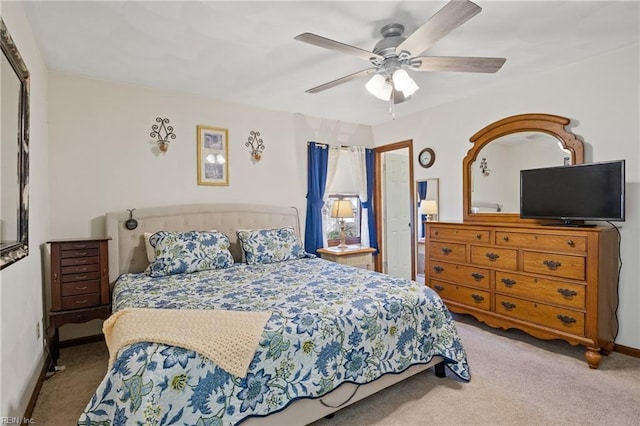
[462,114,584,222]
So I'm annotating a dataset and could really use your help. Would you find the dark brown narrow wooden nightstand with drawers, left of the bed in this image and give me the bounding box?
[47,237,111,365]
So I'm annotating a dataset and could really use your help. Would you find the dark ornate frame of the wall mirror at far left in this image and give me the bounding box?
[0,17,29,269]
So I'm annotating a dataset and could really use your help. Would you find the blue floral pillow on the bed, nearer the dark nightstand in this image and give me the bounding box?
[149,231,233,277]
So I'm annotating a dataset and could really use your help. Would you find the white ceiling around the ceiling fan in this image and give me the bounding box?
[24,0,640,125]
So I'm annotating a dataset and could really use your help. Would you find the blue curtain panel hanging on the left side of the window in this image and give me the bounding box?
[304,142,329,254]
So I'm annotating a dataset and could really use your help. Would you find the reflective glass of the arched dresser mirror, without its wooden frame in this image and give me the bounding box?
[471,132,571,213]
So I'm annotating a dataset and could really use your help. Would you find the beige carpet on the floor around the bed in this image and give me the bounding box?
[33,317,640,426]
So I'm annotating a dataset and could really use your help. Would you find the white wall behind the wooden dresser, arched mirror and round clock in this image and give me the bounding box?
[373,44,640,348]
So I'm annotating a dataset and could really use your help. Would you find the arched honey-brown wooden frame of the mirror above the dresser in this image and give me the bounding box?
[462,114,584,223]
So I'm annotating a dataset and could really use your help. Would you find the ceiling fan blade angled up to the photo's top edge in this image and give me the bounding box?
[396,0,482,56]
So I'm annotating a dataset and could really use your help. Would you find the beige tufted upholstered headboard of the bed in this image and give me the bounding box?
[106,204,301,283]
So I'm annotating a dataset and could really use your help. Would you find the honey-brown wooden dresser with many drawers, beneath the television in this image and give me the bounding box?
[425,222,618,368]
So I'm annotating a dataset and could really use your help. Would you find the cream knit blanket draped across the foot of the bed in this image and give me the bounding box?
[102,308,271,377]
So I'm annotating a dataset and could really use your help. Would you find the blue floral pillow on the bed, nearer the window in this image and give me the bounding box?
[237,227,312,265]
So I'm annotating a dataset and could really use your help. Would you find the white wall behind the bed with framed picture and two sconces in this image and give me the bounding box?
[49,73,373,340]
